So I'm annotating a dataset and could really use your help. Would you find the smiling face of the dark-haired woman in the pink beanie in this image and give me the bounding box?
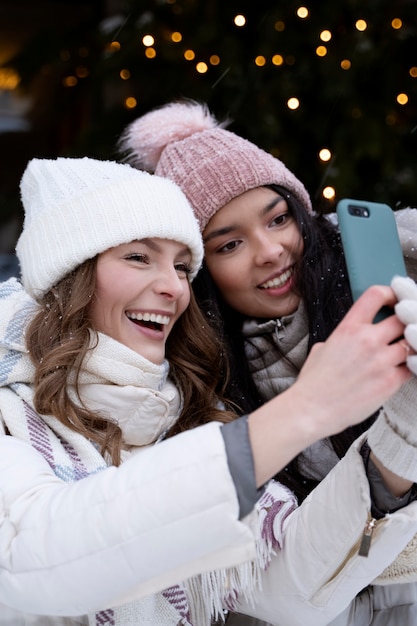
[203,187,303,319]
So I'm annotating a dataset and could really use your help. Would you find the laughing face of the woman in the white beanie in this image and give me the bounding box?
[90,238,191,364]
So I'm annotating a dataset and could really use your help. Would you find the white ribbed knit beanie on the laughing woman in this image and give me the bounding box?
[16,157,203,297]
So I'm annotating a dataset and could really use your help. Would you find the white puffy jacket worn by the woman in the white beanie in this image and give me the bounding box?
[0,416,417,626]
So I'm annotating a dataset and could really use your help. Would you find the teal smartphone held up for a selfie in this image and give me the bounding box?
[336,198,407,322]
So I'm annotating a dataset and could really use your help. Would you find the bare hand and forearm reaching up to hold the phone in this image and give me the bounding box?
[249,286,411,485]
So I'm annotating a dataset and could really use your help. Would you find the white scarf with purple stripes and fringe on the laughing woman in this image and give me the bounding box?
[0,279,296,626]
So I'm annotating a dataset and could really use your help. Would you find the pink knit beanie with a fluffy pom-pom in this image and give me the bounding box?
[119,101,312,231]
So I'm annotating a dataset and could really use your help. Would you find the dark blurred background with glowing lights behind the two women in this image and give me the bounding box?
[0,0,417,272]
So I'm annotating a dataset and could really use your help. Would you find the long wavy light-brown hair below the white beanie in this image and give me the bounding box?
[26,257,236,465]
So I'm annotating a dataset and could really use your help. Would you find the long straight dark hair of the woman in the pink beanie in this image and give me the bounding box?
[193,185,375,501]
